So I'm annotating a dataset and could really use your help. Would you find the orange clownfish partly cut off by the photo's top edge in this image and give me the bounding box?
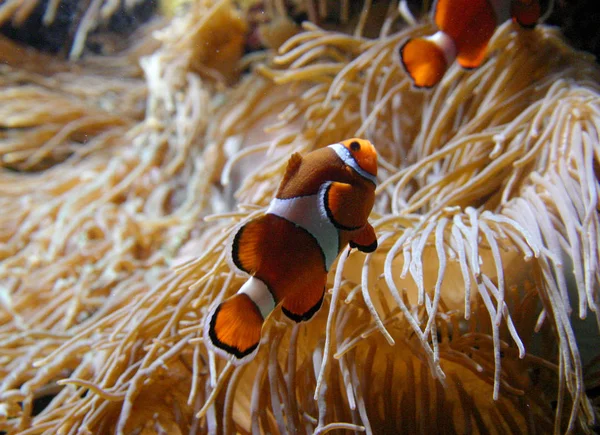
[400,0,541,88]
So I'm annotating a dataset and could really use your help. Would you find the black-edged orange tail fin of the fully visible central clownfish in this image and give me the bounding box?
[204,293,264,365]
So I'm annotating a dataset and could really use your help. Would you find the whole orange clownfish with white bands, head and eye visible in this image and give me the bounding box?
[204,139,377,365]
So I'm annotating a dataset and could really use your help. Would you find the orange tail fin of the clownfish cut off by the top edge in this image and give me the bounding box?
[400,32,456,88]
